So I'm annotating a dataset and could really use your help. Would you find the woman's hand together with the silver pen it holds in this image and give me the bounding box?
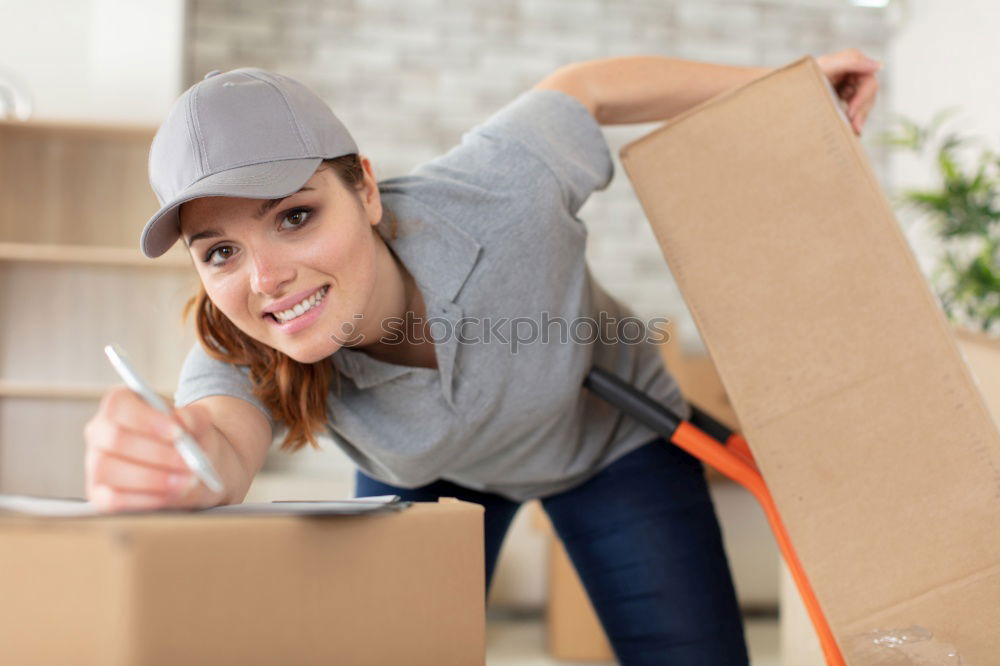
[84,346,224,512]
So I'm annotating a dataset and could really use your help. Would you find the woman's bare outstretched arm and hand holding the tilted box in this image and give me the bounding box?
[534,49,881,134]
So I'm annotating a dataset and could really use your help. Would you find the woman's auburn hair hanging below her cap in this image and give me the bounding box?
[182,154,396,452]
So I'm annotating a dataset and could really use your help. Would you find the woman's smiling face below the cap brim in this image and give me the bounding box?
[180,159,382,363]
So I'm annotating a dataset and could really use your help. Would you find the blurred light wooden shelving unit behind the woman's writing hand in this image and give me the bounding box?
[0,122,197,496]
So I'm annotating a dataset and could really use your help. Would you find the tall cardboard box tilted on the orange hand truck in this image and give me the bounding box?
[621,58,1000,664]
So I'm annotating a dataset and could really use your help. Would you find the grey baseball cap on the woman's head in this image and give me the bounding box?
[139,67,358,257]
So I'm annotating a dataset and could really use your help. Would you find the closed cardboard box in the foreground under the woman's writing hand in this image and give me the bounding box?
[0,499,486,666]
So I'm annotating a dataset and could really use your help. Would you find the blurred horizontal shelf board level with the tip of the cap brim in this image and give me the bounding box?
[0,243,192,270]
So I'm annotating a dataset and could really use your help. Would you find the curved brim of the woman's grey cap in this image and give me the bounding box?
[139,157,323,257]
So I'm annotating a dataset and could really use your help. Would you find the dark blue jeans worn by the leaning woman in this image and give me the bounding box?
[355,439,749,666]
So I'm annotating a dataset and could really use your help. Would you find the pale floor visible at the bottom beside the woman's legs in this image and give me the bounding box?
[486,617,781,666]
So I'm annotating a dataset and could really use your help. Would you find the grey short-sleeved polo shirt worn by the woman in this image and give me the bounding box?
[175,90,689,501]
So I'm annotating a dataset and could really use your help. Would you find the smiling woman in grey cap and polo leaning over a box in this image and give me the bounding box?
[85,50,879,665]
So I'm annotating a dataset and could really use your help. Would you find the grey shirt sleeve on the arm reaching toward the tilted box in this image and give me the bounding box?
[410,89,614,215]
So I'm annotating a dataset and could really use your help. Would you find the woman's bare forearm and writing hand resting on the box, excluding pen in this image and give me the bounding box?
[84,387,272,512]
